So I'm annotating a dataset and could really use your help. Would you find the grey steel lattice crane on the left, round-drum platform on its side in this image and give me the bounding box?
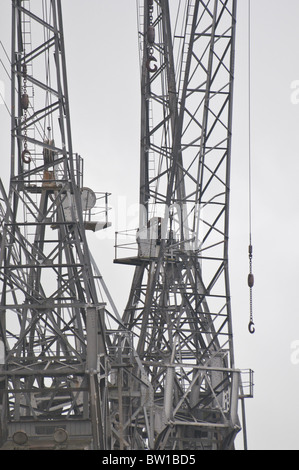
[0,0,124,449]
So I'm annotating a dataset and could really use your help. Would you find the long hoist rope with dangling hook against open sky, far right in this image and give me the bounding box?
[248,0,255,334]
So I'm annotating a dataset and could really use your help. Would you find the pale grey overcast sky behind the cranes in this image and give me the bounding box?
[0,0,299,450]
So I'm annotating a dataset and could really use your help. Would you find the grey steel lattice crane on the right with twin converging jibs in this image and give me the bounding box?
[115,0,253,450]
